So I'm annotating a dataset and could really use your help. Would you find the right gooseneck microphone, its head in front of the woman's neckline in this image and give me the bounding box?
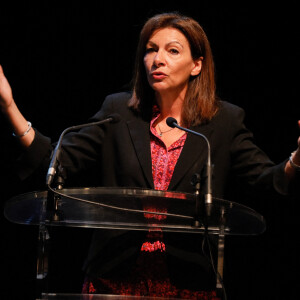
[166,117,212,216]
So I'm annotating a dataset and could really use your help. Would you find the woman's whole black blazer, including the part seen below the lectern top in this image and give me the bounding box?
[19,93,288,284]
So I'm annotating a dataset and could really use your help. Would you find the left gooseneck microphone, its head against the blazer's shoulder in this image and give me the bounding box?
[46,114,121,186]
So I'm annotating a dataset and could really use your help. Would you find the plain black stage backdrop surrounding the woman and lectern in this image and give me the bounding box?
[0,0,300,300]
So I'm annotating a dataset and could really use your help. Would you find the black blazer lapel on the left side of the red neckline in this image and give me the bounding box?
[127,119,154,189]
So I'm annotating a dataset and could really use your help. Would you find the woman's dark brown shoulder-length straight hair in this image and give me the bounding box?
[129,13,218,126]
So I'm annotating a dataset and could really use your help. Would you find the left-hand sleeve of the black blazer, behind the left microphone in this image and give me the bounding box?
[15,95,127,188]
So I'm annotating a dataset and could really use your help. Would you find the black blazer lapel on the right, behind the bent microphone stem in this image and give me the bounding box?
[169,125,212,190]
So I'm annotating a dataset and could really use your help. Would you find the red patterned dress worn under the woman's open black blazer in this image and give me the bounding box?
[82,108,220,300]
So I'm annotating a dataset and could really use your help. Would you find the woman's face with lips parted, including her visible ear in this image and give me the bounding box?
[144,27,202,94]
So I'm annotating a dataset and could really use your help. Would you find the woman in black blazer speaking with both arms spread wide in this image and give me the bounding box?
[0,13,300,299]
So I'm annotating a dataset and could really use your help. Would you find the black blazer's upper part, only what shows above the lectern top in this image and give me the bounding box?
[18,93,288,197]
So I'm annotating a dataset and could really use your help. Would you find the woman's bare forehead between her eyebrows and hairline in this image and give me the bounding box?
[148,27,189,46]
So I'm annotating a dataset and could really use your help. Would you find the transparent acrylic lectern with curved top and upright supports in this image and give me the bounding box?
[4,187,265,300]
